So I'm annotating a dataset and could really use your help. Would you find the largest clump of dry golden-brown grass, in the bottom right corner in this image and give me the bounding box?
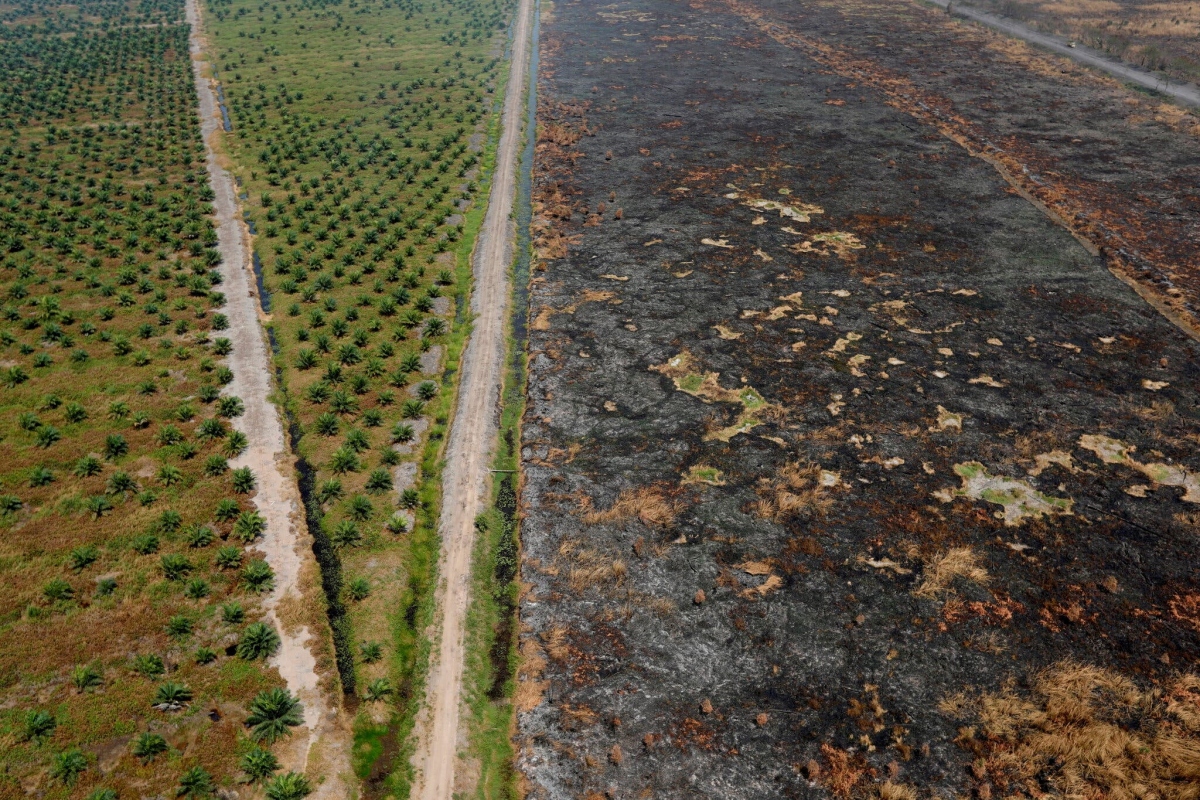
[943,661,1200,800]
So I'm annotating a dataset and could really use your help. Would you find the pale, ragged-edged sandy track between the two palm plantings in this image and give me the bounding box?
[187,0,350,800]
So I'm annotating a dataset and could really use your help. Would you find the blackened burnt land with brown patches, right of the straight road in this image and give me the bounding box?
[517,0,1200,799]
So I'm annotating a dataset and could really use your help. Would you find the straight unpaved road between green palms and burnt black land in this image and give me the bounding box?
[413,0,534,800]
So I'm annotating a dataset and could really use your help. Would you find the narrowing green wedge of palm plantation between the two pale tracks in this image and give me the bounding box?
[206,1,511,796]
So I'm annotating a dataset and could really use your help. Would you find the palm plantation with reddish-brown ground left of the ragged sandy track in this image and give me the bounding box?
[0,2,302,799]
